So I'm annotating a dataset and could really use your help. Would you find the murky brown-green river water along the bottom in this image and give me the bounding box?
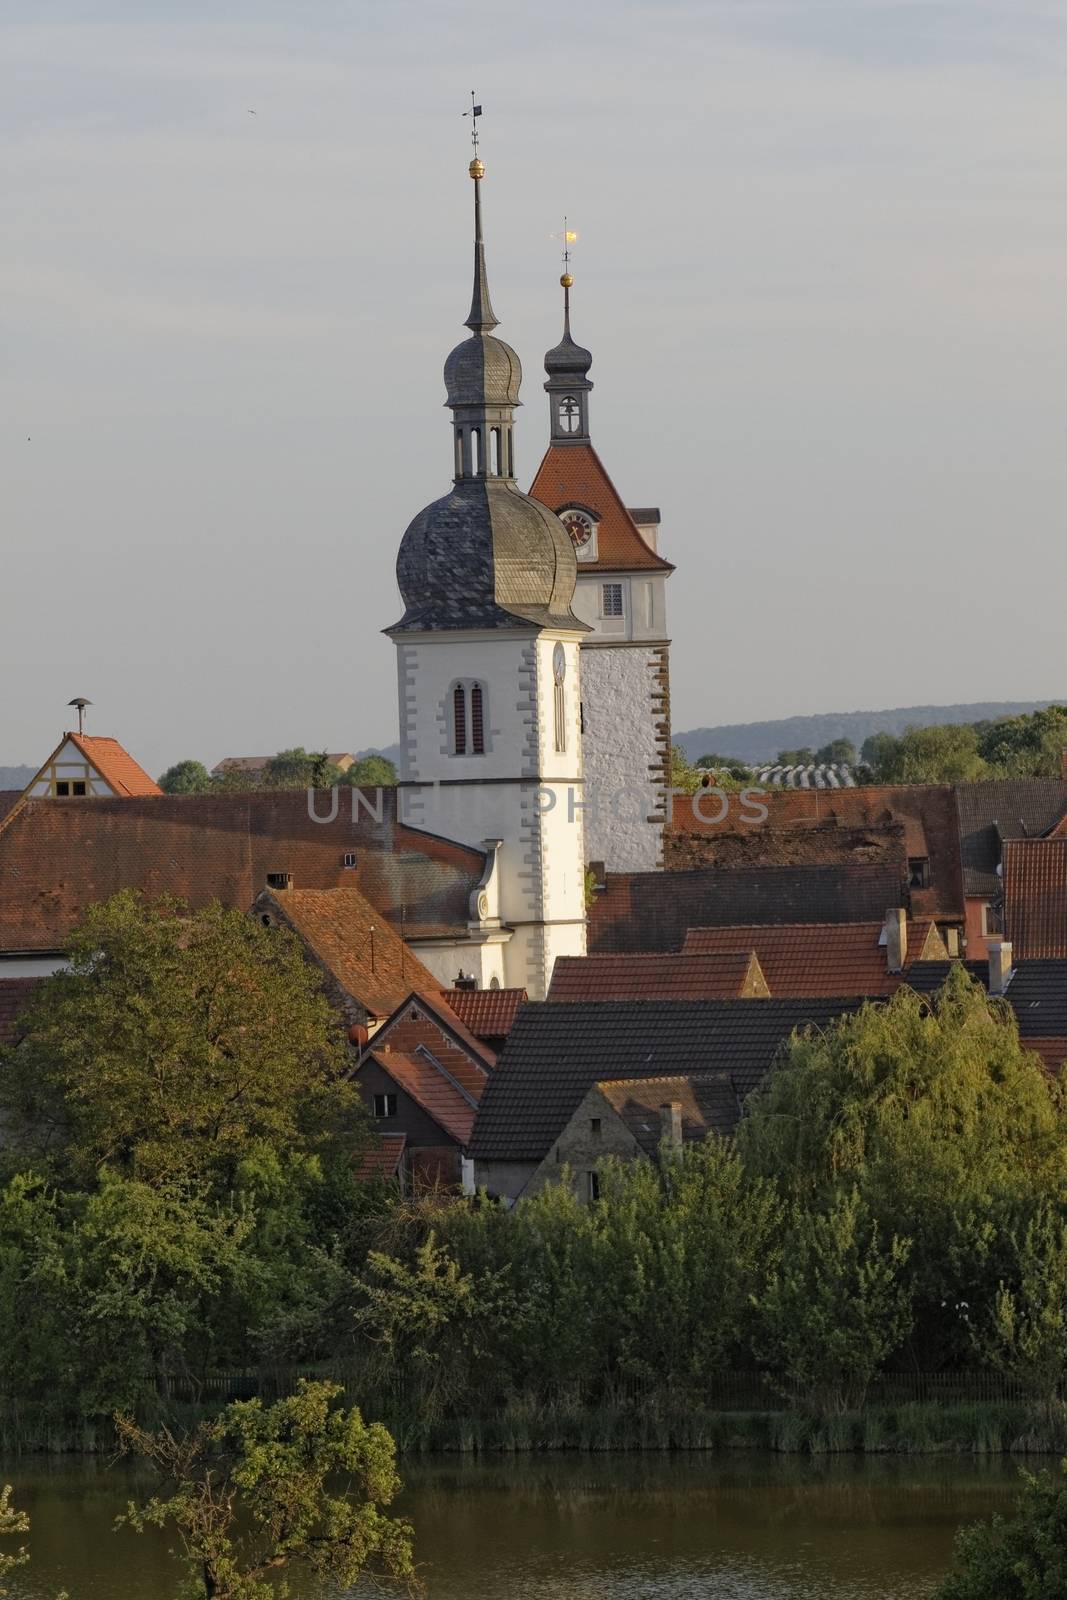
[0,1453,1019,1600]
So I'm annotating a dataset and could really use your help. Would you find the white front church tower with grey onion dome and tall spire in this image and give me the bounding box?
[387,154,587,1000]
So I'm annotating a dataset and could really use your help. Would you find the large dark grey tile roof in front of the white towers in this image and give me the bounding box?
[470,998,862,1162]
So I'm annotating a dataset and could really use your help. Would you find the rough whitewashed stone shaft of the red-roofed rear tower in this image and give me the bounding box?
[582,646,662,872]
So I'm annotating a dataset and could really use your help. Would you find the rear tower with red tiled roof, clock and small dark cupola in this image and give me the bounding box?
[530,270,673,872]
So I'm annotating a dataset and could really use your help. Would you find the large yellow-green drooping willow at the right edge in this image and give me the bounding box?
[737,968,1067,1368]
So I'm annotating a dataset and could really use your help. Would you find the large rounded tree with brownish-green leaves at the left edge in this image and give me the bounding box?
[0,890,360,1192]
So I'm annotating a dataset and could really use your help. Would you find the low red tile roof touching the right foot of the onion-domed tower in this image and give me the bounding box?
[549,946,773,1003]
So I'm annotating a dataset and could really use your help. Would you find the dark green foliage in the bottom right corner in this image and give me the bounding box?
[934,1462,1067,1600]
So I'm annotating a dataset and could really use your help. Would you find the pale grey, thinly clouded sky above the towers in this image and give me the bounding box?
[0,0,1067,773]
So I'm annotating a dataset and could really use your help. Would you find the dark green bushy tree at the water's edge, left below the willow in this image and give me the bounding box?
[757,1190,910,1414]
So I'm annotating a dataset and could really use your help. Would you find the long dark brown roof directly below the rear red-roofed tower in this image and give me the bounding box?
[589,866,907,953]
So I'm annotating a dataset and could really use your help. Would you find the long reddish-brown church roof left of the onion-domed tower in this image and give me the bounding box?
[0,789,485,950]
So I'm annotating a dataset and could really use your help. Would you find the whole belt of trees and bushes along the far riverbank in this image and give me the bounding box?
[0,894,1067,1448]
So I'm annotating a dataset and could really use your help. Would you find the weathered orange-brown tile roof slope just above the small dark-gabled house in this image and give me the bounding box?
[256,888,437,1018]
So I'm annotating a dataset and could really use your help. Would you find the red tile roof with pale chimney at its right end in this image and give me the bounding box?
[683,922,949,1000]
